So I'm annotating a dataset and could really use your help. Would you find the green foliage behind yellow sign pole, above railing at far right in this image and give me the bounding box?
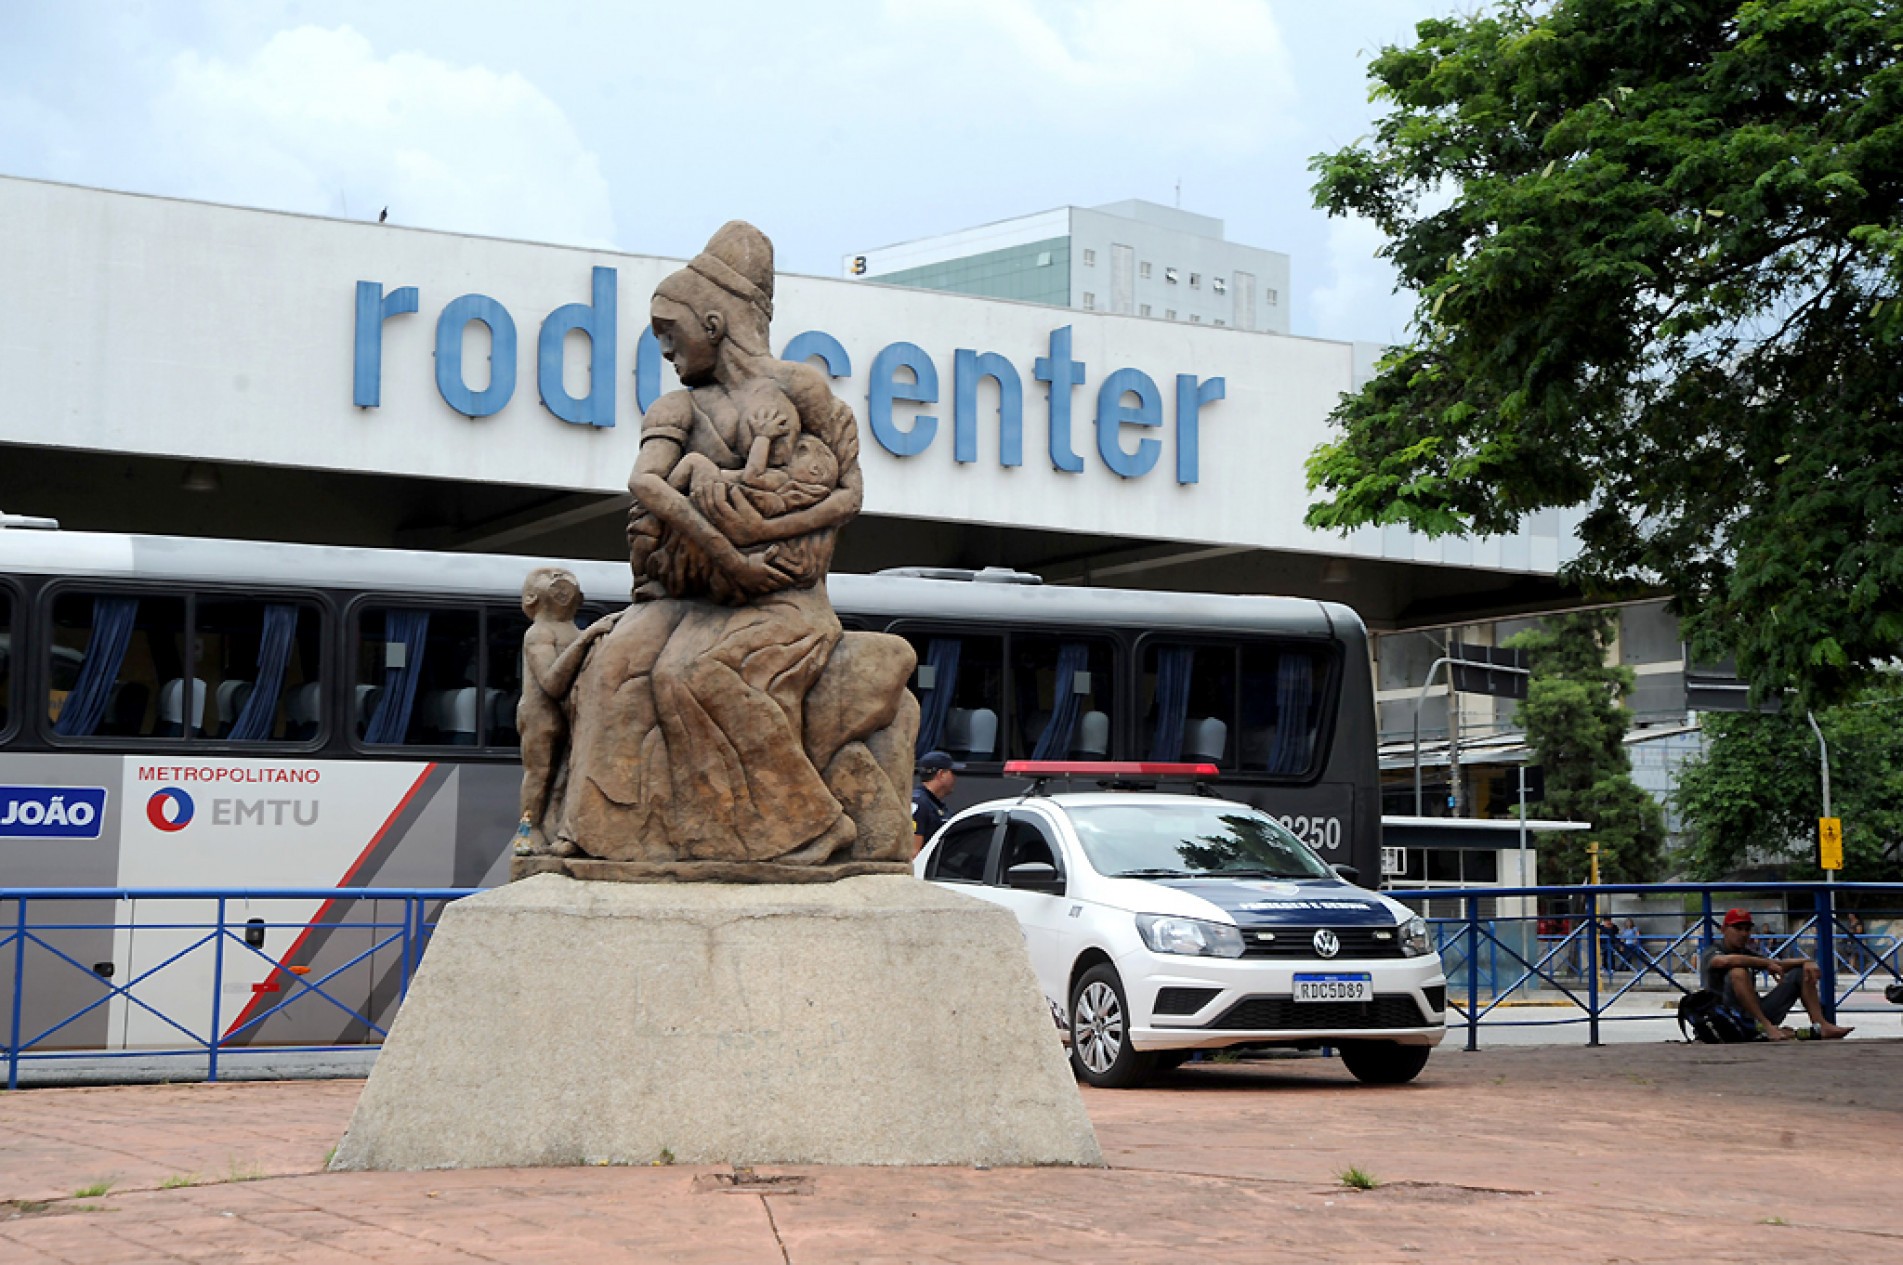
[1677,681,1903,883]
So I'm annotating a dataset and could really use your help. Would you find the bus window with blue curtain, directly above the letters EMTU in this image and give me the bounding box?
[192,597,322,742]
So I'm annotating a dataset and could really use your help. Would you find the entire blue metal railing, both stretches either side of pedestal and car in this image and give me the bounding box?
[11,883,1903,1088]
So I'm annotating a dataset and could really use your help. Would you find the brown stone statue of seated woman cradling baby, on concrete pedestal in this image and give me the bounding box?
[516,221,919,881]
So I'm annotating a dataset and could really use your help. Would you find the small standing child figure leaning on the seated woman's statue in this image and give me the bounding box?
[516,567,615,856]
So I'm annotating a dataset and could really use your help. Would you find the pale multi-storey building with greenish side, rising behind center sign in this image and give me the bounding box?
[841,198,1288,335]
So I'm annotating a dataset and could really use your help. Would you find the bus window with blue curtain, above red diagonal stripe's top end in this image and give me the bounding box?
[350,607,481,746]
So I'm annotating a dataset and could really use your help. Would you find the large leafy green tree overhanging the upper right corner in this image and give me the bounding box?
[1307,0,1903,706]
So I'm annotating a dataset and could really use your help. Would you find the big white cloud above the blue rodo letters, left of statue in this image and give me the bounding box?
[152,27,615,245]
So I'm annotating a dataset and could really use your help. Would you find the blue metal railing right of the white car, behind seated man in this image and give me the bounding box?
[1389,883,1903,1050]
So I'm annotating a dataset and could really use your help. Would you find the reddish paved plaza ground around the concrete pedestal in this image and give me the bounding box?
[0,1039,1903,1265]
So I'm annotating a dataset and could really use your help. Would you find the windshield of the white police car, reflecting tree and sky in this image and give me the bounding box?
[1069,797,1334,879]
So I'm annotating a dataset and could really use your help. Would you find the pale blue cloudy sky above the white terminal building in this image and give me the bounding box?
[0,0,1467,342]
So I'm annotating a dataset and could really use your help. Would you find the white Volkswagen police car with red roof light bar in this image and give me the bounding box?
[913,761,1446,1086]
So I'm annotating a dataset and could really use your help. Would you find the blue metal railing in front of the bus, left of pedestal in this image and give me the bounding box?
[0,888,480,1088]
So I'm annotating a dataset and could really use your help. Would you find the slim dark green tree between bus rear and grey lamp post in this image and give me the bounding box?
[1507,611,1665,883]
